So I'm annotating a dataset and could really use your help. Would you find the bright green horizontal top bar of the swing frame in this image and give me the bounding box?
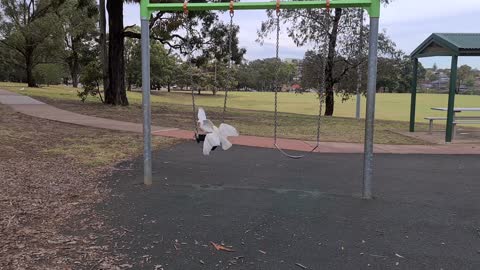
[142,0,380,17]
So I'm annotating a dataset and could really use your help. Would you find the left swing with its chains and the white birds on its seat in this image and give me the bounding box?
[183,1,239,155]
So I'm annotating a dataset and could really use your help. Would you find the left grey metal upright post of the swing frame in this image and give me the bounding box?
[141,16,152,186]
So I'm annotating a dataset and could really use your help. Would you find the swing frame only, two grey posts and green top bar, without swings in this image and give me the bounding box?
[140,0,380,199]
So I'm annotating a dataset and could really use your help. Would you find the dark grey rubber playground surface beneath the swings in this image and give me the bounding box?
[101,142,480,269]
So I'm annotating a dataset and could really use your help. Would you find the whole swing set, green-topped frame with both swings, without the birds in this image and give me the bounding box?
[140,0,380,199]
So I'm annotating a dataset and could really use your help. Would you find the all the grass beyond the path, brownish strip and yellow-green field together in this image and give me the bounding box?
[0,83,468,144]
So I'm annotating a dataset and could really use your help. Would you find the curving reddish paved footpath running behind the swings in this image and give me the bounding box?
[0,89,480,155]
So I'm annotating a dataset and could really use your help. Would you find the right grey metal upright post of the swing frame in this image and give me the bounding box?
[362,17,379,199]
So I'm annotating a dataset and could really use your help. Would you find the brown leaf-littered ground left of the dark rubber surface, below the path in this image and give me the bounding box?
[0,105,175,269]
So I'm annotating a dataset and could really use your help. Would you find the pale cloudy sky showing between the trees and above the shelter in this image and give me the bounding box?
[124,0,480,69]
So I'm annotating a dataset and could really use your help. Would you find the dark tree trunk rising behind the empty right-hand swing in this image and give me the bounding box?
[325,8,342,116]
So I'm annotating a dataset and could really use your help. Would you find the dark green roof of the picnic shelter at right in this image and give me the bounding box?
[410,33,480,58]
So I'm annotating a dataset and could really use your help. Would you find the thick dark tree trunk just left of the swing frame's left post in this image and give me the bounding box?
[105,0,128,106]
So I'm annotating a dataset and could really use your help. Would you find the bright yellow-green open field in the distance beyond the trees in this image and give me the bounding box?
[0,80,480,122]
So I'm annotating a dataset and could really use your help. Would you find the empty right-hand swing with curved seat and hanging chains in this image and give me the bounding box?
[273,0,330,159]
